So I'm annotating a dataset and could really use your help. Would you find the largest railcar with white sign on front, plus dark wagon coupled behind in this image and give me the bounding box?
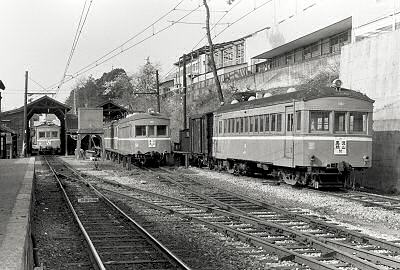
[180,87,374,189]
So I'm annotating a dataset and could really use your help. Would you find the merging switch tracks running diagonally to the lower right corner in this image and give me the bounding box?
[58,158,400,269]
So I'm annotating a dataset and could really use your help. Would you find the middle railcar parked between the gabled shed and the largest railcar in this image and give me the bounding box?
[104,112,171,166]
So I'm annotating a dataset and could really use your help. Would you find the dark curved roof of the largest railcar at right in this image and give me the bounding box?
[216,86,374,113]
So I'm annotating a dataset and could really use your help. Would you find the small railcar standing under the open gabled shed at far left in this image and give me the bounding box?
[32,122,61,154]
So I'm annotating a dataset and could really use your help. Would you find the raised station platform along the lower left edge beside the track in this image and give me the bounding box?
[0,158,35,270]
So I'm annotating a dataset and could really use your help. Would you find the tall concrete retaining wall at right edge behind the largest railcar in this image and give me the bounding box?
[340,31,400,193]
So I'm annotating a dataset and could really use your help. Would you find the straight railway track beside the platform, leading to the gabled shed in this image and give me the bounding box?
[45,157,190,269]
